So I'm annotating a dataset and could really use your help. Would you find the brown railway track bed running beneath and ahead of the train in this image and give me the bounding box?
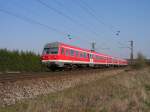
[0,68,125,83]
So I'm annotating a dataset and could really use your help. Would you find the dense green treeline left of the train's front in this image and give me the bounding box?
[0,49,45,72]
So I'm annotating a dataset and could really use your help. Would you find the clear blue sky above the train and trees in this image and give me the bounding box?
[0,0,150,58]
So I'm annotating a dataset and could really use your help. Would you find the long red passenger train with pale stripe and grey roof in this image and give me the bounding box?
[41,42,128,69]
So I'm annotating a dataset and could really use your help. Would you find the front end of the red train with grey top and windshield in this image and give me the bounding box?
[41,42,59,69]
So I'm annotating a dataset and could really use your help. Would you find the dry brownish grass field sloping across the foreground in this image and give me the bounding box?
[0,68,150,112]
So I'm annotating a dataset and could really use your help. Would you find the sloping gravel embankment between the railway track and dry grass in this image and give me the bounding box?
[0,69,124,106]
